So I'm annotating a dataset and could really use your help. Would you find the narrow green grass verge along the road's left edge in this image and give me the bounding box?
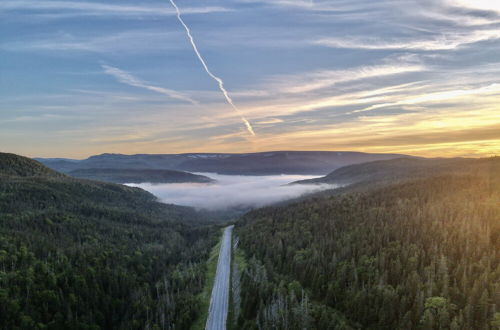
[191,229,224,330]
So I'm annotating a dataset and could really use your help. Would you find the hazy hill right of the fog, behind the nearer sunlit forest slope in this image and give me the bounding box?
[293,157,498,184]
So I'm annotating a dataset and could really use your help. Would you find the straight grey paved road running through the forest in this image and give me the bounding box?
[205,226,234,330]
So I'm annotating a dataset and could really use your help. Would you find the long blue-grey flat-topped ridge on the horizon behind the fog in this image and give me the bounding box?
[37,151,410,175]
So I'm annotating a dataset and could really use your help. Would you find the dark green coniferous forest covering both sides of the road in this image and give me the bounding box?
[0,154,500,330]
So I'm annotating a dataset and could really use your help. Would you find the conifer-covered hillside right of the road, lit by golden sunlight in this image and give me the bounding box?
[235,157,500,330]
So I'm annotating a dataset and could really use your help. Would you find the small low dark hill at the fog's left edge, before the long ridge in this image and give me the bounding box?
[68,168,214,183]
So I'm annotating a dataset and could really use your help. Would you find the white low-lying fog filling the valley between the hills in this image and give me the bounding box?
[128,173,336,211]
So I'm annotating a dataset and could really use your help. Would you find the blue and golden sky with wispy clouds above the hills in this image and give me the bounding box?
[0,0,500,158]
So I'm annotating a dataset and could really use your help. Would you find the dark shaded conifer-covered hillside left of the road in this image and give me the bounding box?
[0,154,219,329]
